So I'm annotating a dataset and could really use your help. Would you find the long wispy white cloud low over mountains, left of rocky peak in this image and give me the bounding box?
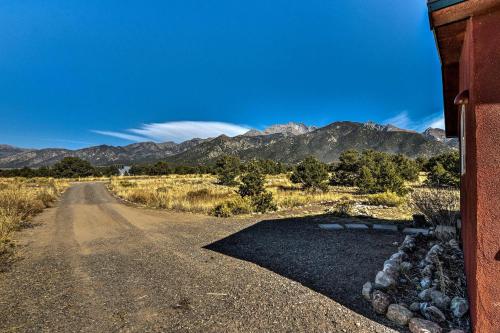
[92,121,249,142]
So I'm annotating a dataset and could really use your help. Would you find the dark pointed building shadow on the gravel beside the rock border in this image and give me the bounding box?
[205,215,404,327]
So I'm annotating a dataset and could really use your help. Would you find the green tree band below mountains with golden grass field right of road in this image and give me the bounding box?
[0,150,460,224]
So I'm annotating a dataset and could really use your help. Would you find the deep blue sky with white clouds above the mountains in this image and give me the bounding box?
[0,0,443,148]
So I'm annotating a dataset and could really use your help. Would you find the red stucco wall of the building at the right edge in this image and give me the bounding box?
[460,11,500,333]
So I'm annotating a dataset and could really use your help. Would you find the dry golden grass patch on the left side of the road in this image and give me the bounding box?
[0,178,68,255]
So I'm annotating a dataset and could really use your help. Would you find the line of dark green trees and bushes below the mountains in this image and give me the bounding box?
[0,150,460,189]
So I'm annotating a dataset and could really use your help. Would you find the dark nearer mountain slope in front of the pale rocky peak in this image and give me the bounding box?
[167,122,452,163]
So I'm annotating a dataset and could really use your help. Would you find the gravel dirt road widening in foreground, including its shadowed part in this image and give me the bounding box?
[0,183,396,332]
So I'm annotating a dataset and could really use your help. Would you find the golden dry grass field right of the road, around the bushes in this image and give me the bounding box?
[109,175,418,219]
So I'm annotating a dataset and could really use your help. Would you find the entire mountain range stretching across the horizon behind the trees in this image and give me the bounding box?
[0,121,457,168]
